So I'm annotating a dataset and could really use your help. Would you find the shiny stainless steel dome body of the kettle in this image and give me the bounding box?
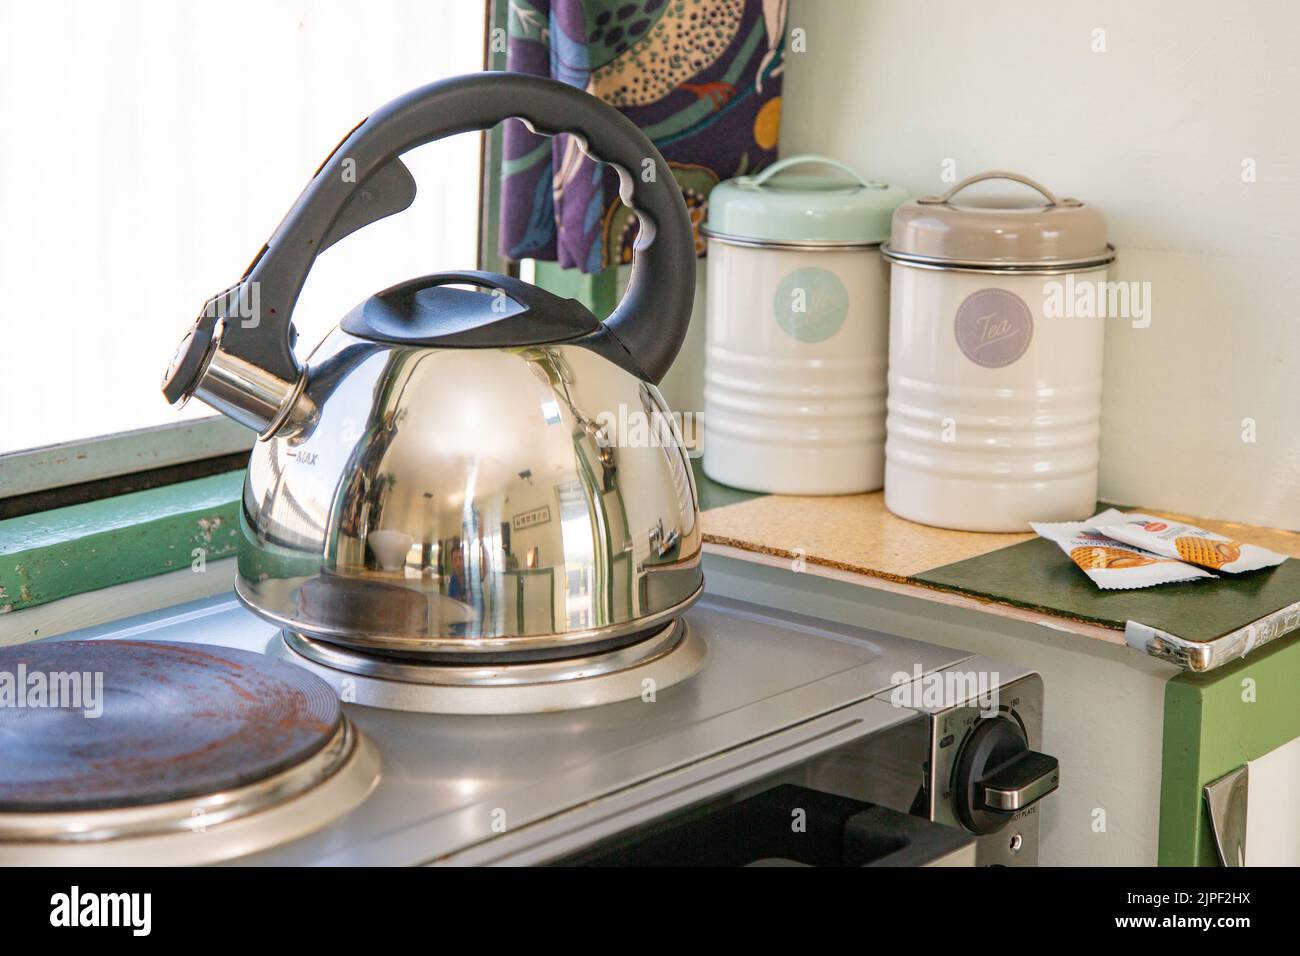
[237,330,702,659]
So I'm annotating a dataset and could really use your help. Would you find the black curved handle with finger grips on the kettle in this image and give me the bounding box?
[239,73,696,382]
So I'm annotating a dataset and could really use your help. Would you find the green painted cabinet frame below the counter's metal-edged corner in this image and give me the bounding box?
[1158,637,1300,866]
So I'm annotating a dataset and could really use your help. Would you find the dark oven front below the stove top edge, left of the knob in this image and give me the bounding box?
[550,701,976,866]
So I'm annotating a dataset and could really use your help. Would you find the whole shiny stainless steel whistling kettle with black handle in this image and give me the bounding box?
[170,73,703,663]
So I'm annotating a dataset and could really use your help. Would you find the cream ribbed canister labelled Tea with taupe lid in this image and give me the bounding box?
[884,172,1115,531]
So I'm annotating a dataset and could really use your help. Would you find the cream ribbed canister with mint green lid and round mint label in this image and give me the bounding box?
[703,156,907,494]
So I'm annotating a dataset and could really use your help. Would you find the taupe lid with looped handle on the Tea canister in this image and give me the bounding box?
[885,172,1115,272]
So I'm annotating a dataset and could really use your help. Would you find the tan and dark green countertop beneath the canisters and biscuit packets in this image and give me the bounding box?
[696,463,1300,671]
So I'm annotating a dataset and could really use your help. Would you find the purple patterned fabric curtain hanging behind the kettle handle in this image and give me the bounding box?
[501,0,787,273]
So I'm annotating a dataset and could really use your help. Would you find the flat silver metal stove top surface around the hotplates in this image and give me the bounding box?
[0,596,969,865]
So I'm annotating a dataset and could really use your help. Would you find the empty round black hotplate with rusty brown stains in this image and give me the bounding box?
[0,641,343,813]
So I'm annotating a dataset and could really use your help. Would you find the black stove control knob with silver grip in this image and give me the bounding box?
[953,717,1061,834]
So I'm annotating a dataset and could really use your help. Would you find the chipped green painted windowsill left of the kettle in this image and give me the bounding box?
[0,471,243,613]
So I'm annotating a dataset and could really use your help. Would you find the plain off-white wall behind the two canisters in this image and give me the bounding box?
[781,0,1300,529]
